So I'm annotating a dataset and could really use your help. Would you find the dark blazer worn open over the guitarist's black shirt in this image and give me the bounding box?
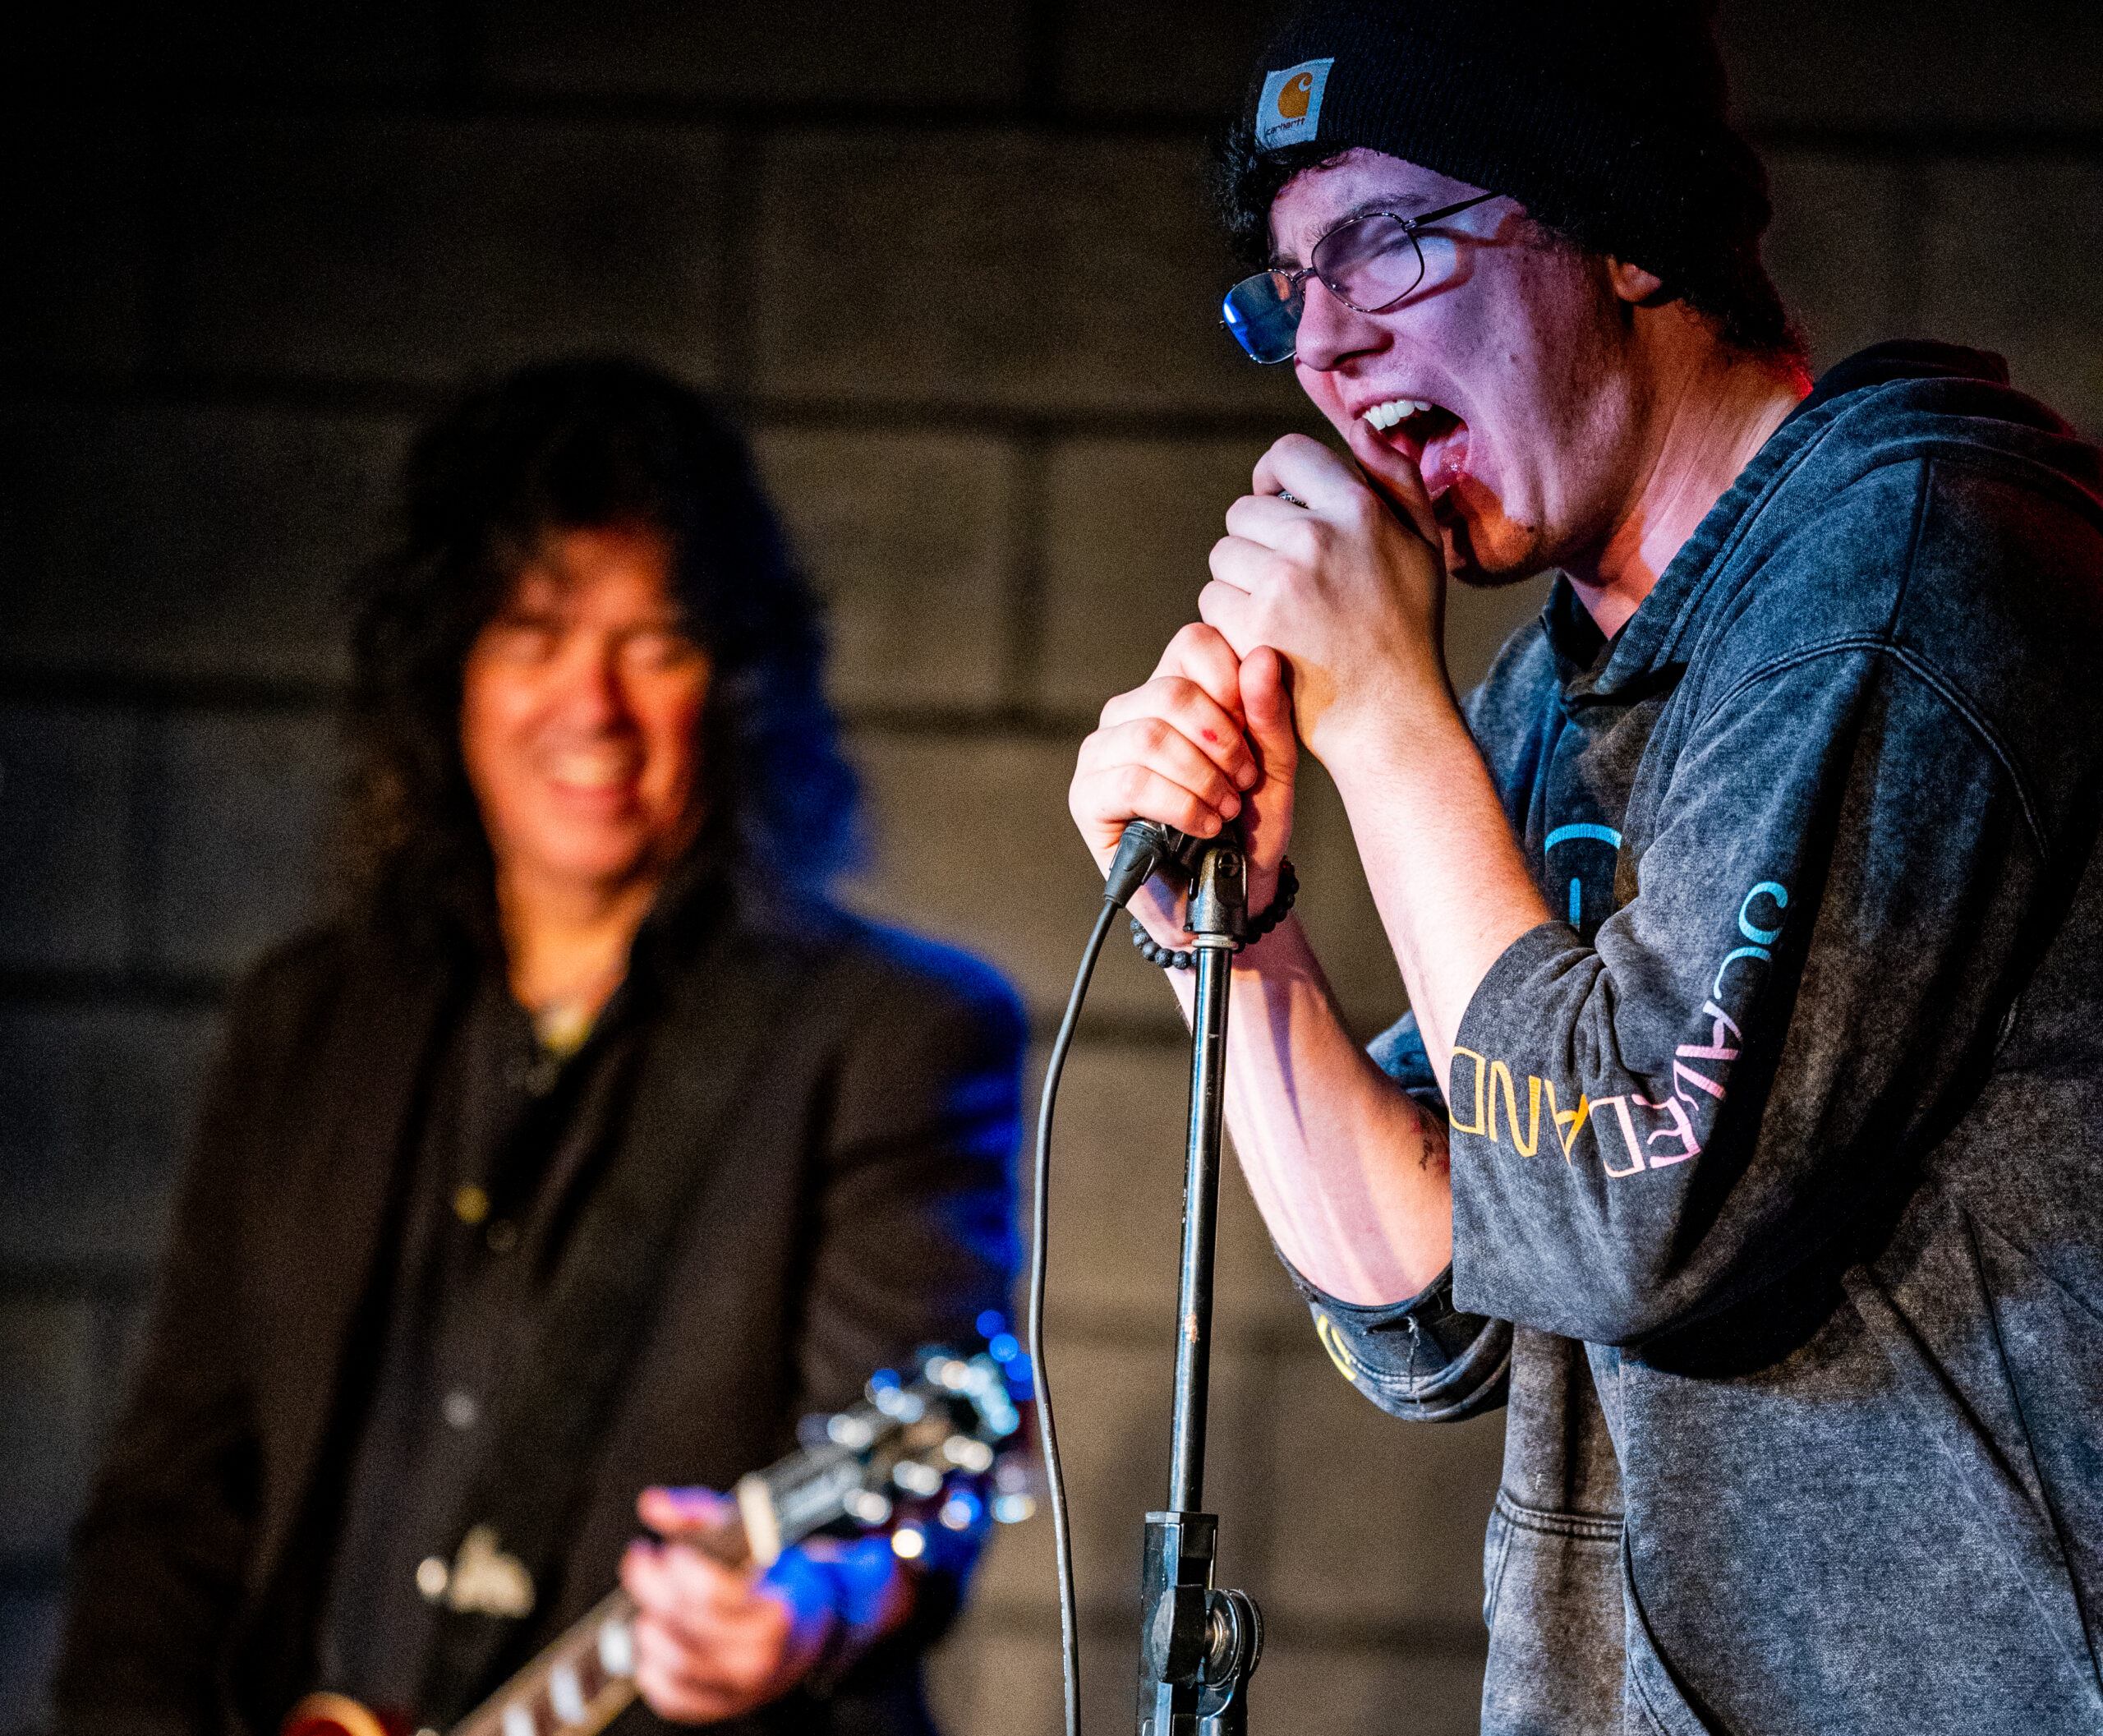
[57,891,1024,1736]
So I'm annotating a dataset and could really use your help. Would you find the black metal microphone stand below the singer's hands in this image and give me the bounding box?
[1140,829,1264,1736]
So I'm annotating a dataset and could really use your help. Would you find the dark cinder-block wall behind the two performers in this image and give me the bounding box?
[0,0,2103,1736]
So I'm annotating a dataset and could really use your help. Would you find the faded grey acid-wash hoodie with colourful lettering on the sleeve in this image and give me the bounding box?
[1310,345,2103,1736]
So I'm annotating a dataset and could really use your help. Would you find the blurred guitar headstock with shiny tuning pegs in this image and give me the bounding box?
[736,1311,1037,1563]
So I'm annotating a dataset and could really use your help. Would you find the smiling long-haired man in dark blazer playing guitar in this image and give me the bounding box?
[57,360,1024,1736]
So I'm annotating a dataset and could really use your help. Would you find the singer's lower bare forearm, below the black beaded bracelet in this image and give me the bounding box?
[1167,900,1453,1302]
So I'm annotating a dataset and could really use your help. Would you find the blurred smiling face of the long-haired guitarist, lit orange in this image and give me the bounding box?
[461,528,709,900]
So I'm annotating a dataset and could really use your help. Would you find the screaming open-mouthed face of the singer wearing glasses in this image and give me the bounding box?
[1270,150,1646,585]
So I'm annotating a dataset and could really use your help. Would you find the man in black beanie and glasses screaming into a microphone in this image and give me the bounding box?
[1070,0,2103,1736]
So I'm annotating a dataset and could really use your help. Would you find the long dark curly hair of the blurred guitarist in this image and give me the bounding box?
[345,357,856,945]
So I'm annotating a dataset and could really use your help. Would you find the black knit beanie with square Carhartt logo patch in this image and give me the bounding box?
[1231,0,1779,314]
